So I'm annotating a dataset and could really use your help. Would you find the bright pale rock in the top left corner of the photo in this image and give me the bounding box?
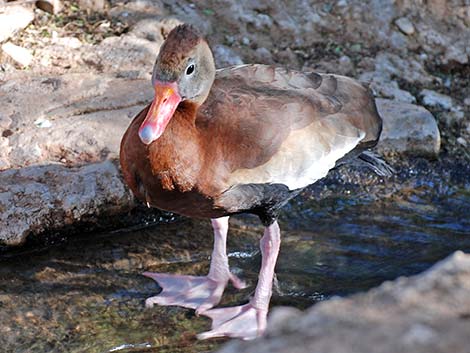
[0,5,34,43]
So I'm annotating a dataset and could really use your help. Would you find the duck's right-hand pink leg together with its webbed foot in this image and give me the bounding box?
[198,222,281,339]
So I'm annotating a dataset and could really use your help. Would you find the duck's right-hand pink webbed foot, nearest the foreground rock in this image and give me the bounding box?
[197,303,268,340]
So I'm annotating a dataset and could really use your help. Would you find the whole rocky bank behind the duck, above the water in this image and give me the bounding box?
[0,0,470,245]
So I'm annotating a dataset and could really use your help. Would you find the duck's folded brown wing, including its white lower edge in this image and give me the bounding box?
[196,65,381,190]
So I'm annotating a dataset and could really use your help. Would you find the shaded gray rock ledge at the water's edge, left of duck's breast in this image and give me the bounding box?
[0,161,133,245]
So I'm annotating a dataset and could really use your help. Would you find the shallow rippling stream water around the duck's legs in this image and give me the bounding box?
[0,185,470,353]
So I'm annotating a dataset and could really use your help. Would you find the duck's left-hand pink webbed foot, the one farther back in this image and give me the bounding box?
[143,272,245,314]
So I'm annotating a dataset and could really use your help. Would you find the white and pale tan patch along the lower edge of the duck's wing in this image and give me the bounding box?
[228,114,365,190]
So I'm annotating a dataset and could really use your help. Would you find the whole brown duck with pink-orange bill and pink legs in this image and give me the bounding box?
[121,25,388,339]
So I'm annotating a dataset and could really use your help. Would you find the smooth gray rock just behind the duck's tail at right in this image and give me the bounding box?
[376,99,441,157]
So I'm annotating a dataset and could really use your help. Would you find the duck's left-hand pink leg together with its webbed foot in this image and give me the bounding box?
[144,217,245,314]
